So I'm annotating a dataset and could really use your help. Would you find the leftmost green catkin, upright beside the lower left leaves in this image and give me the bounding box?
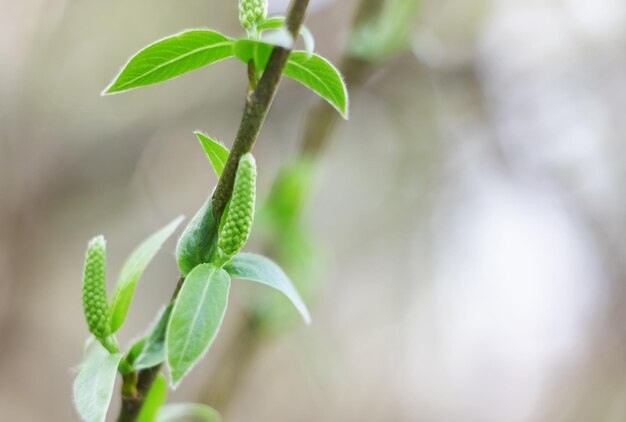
[83,236,111,342]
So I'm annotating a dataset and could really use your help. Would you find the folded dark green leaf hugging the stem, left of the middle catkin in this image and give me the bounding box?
[176,194,219,275]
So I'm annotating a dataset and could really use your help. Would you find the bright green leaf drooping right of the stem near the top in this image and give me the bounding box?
[285,51,348,119]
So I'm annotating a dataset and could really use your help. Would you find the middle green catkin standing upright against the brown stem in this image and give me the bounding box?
[218,153,256,262]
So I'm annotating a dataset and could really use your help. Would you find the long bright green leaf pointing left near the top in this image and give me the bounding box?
[103,29,233,95]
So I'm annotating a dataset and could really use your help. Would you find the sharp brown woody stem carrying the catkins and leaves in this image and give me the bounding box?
[118,0,309,422]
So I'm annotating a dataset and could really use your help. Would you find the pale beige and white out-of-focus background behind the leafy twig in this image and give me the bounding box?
[0,0,626,422]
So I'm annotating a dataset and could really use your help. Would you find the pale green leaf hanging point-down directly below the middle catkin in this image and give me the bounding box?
[166,264,230,388]
